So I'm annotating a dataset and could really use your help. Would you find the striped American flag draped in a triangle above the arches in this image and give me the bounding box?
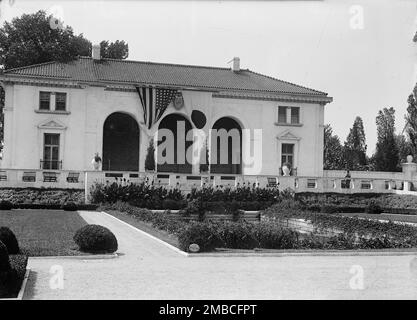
[136,87,177,129]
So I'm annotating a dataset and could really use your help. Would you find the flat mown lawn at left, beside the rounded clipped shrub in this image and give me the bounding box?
[0,210,87,257]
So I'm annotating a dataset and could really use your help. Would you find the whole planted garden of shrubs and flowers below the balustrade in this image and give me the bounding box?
[92,184,417,252]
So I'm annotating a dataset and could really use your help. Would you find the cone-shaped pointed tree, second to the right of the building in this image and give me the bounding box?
[343,117,368,170]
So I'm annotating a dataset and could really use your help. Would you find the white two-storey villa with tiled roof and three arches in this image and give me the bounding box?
[1,48,332,185]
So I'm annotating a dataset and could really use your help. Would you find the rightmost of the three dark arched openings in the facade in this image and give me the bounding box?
[210,117,242,174]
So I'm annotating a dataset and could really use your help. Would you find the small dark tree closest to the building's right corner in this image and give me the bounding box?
[323,124,344,170]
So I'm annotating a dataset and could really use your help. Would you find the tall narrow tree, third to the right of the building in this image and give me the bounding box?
[374,107,399,171]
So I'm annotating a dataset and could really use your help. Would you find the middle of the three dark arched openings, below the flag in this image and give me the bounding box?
[157,113,192,173]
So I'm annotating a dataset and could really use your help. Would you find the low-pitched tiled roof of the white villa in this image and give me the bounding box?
[4,57,329,98]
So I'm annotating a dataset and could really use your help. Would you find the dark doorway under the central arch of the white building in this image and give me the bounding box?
[157,114,192,173]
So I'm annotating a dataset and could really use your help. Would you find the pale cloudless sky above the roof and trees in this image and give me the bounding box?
[0,0,417,154]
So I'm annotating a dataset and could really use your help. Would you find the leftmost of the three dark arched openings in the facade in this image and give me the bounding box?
[102,112,139,171]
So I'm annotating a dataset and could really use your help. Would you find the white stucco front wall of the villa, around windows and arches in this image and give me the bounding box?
[2,83,324,177]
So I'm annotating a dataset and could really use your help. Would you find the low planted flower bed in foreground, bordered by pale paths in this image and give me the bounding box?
[102,199,417,252]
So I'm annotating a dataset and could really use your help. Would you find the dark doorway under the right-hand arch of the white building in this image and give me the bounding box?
[210,117,242,174]
